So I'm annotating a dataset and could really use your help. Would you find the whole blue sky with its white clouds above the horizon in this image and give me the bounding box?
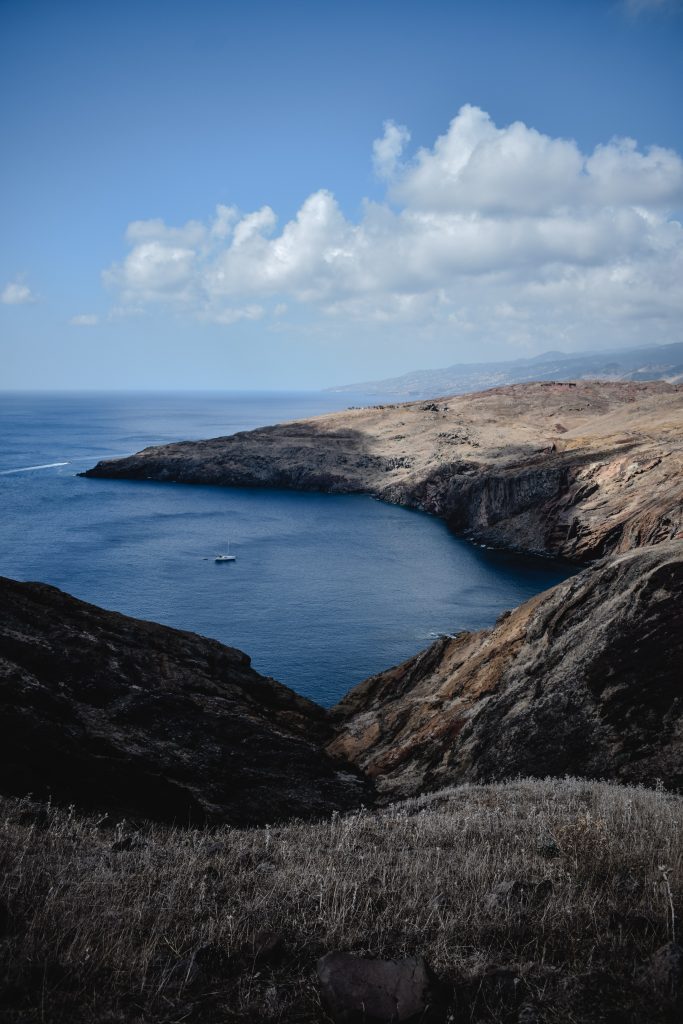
[0,0,683,389]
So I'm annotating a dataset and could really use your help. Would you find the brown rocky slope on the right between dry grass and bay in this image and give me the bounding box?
[329,541,683,799]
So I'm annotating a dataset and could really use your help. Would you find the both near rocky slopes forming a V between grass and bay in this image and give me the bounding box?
[0,541,683,825]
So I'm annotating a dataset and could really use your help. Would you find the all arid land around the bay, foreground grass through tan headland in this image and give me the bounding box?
[0,382,683,1024]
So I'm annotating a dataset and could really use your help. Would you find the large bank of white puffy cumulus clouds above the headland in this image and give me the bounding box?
[105,105,683,347]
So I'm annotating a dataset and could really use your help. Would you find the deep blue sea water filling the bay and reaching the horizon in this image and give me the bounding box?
[0,392,571,706]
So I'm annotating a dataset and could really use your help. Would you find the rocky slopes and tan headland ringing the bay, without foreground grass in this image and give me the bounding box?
[0,382,683,824]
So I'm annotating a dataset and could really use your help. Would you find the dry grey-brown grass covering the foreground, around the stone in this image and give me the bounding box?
[0,779,683,1024]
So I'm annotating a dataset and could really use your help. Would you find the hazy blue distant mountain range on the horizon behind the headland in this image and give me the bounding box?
[328,342,683,399]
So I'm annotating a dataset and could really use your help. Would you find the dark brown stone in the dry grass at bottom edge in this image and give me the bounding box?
[316,953,430,1024]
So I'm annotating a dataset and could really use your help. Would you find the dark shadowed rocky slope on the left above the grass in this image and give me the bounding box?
[0,578,368,824]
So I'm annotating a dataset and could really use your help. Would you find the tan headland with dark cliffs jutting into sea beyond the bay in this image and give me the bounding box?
[85,382,683,561]
